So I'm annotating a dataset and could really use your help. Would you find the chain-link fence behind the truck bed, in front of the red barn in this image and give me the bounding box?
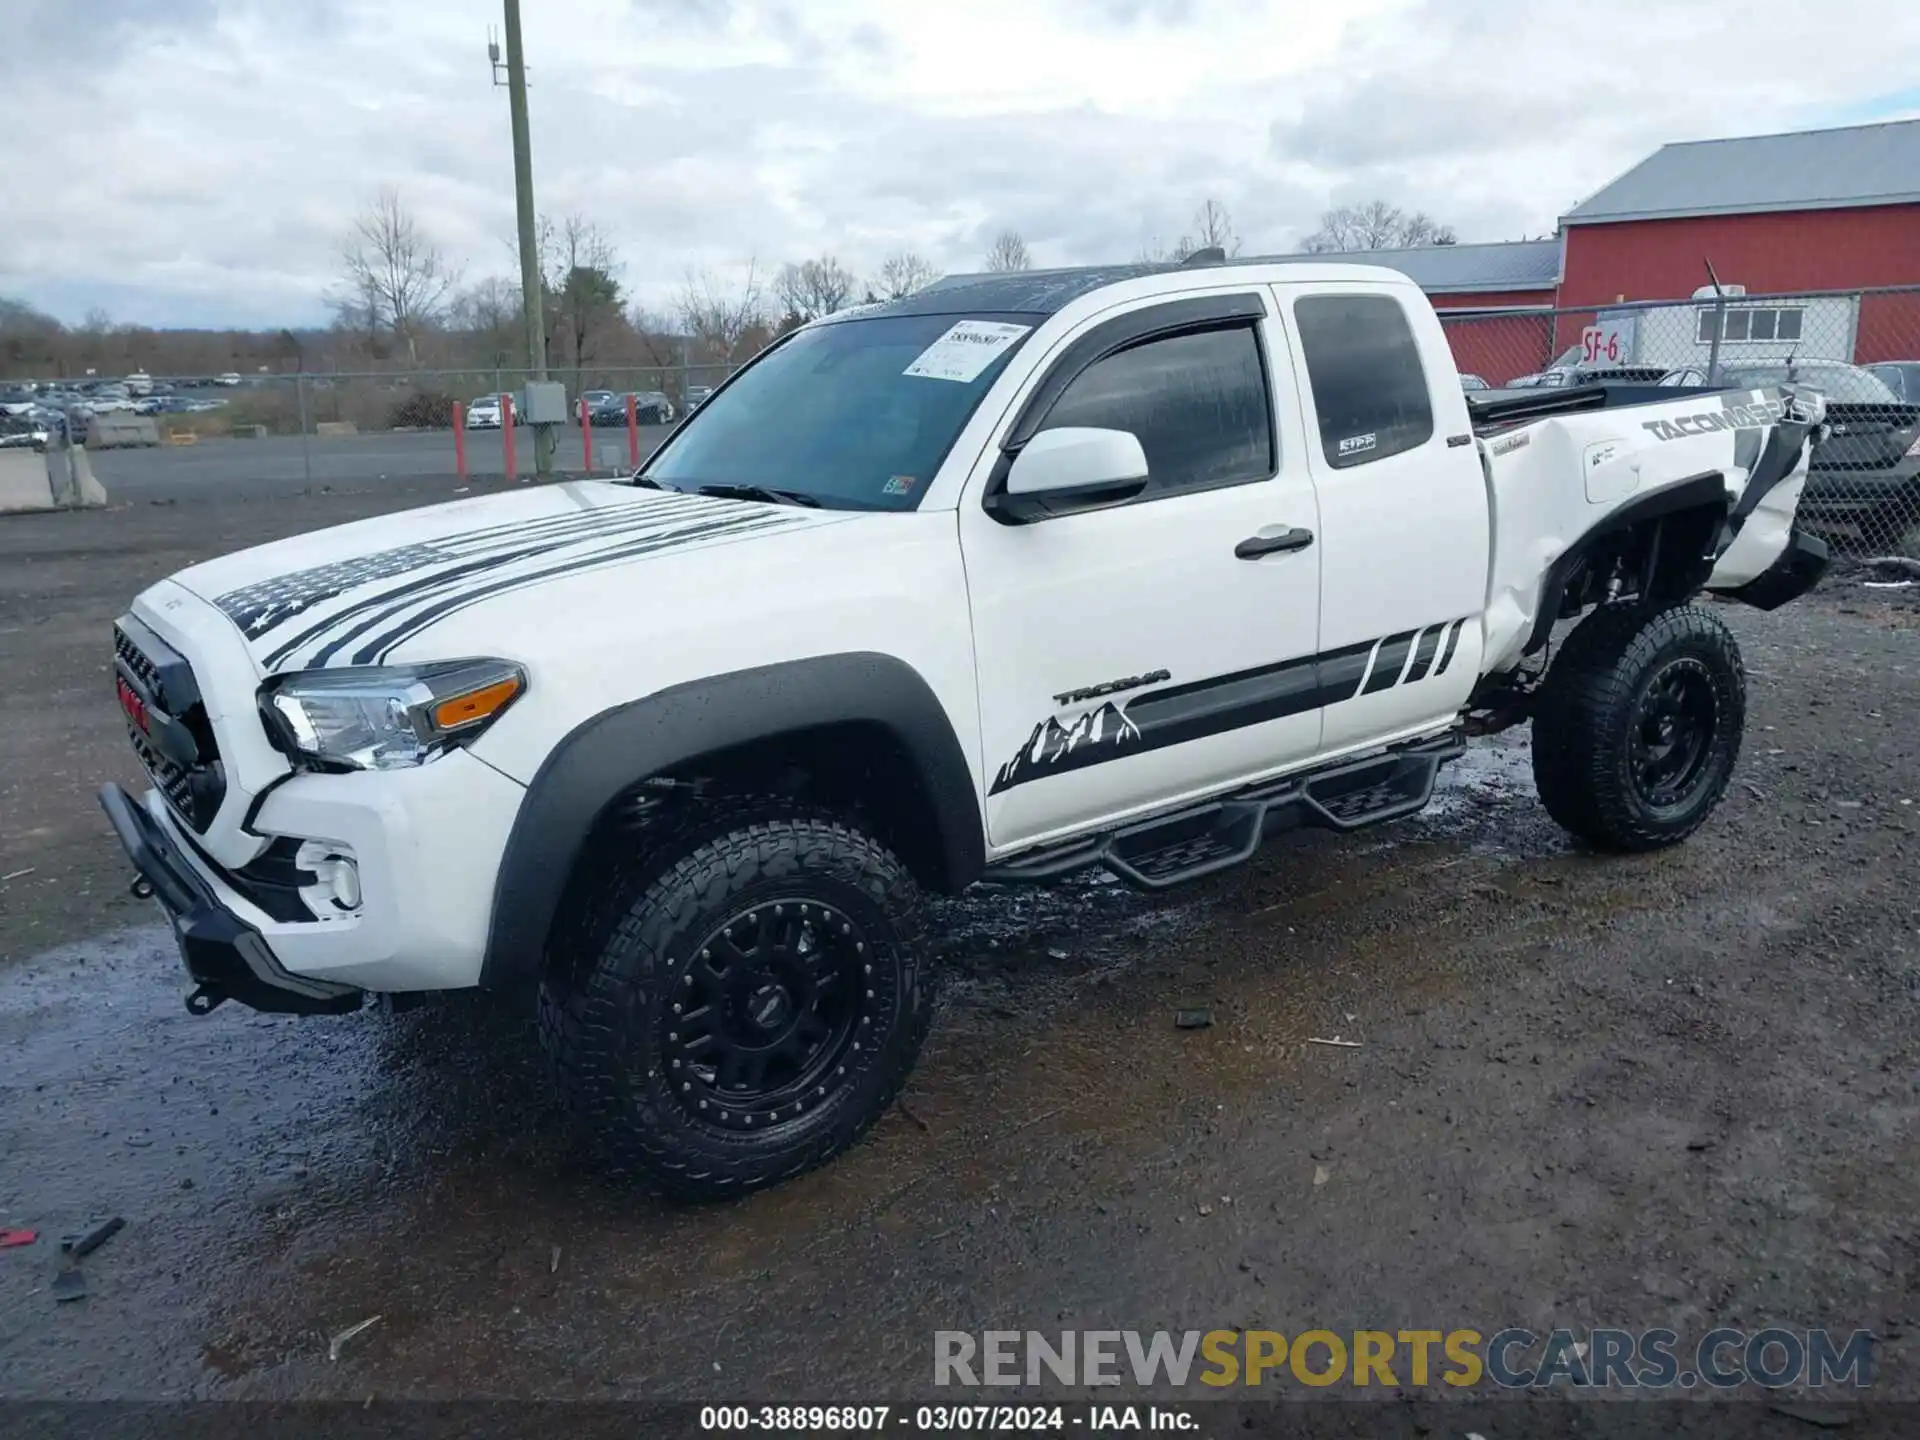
[1440,286,1920,555]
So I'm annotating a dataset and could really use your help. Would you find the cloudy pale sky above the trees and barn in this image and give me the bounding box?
[0,0,1920,326]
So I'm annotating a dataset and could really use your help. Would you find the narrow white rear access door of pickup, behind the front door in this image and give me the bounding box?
[1275,282,1492,751]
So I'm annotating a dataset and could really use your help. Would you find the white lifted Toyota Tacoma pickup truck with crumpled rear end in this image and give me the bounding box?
[102,263,1826,1196]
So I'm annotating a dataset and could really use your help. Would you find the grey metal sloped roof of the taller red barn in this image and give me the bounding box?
[1561,119,1920,225]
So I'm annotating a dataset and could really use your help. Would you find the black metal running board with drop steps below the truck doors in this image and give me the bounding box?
[981,732,1467,891]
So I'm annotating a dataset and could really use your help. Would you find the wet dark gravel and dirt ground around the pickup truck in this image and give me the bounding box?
[0,486,1920,1440]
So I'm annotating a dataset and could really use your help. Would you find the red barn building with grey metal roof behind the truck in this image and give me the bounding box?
[1356,121,1920,384]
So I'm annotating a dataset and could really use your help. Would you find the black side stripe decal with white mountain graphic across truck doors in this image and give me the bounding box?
[987,620,1465,795]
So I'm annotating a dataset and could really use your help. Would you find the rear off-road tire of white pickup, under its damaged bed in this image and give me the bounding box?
[1534,605,1747,852]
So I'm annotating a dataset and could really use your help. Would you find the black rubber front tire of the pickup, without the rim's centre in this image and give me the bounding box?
[540,797,933,1200]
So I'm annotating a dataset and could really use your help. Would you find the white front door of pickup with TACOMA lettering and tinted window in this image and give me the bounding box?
[960,286,1321,849]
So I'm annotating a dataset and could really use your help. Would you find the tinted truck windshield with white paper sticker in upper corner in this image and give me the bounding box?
[639,315,1033,511]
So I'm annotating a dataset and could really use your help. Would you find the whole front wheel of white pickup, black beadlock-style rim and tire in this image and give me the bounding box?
[540,801,931,1200]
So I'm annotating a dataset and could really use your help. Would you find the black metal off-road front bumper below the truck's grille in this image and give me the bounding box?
[100,785,365,1016]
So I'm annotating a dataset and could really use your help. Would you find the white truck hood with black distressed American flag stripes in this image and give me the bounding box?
[175,480,852,672]
